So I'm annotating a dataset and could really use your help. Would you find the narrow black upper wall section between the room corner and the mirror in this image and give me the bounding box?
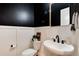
[34,3,49,27]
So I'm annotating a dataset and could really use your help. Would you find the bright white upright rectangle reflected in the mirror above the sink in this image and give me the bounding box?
[60,7,70,26]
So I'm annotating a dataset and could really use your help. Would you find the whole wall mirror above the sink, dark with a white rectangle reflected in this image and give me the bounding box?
[51,3,71,26]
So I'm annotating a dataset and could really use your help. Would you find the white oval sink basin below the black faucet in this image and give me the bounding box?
[43,40,74,55]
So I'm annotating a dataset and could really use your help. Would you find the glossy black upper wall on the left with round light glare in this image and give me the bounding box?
[0,3,34,27]
